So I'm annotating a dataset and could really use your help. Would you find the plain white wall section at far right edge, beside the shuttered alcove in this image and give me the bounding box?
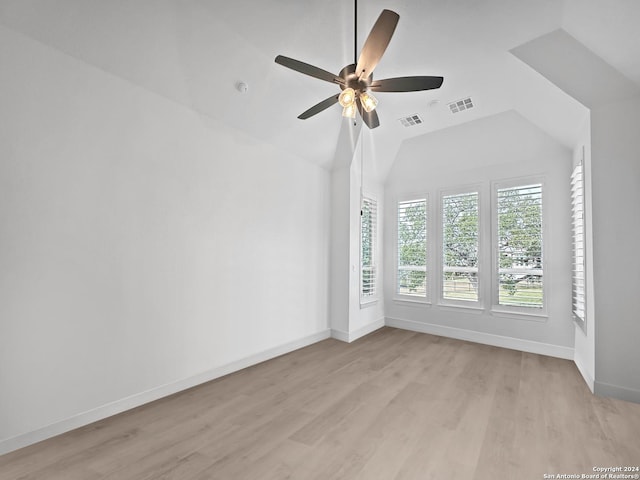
[591,96,640,402]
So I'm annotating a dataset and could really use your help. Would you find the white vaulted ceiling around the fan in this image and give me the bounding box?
[0,0,640,175]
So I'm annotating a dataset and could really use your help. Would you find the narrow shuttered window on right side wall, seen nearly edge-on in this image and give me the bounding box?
[571,162,586,330]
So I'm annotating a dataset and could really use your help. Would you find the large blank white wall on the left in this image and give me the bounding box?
[0,27,329,453]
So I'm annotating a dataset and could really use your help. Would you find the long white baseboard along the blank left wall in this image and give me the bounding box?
[0,329,331,455]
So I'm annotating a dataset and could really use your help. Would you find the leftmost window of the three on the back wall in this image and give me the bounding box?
[396,198,427,298]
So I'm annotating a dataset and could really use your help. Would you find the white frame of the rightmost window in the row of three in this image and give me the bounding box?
[490,176,549,321]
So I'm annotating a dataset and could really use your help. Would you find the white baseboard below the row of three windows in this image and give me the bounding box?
[385,317,573,360]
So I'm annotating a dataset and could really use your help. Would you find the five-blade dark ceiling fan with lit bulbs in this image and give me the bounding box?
[275,0,444,128]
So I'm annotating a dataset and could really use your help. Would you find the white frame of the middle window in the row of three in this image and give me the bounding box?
[433,184,486,310]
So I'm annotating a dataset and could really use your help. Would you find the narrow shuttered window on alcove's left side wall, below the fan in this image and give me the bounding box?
[360,197,378,299]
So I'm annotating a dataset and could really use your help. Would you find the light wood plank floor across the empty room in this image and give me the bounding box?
[0,328,640,480]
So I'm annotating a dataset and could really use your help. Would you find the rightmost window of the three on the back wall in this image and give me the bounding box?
[495,184,544,308]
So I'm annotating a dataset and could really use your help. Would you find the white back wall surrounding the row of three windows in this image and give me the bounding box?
[385,111,574,358]
